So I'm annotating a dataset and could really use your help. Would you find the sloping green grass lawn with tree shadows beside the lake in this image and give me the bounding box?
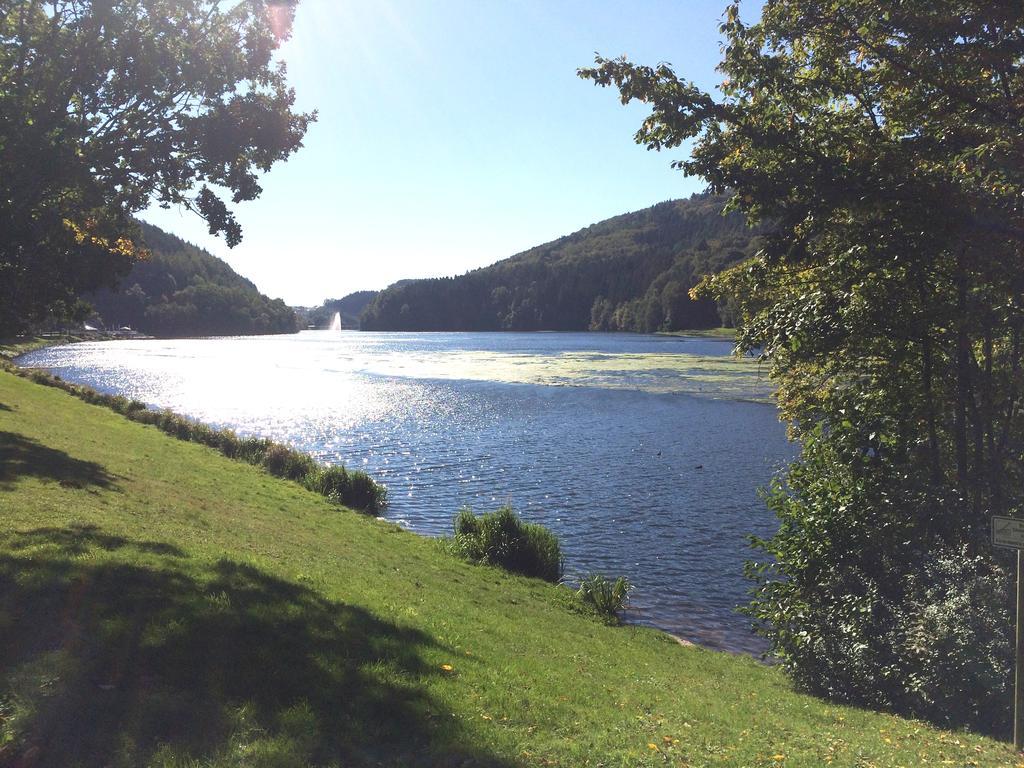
[0,372,1017,768]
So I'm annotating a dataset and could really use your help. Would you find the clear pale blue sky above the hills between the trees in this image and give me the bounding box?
[144,0,726,304]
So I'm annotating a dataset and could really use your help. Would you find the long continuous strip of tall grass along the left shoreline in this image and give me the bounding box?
[3,362,387,514]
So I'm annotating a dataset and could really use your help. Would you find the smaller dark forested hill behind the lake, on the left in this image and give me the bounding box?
[88,223,296,336]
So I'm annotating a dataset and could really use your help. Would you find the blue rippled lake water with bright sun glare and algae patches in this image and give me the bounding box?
[20,332,794,652]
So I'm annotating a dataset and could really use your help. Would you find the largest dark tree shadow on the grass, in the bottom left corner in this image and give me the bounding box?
[0,528,509,768]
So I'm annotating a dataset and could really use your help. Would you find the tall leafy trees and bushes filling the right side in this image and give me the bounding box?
[581,0,1024,731]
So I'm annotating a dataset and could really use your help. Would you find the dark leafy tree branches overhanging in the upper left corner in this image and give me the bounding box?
[0,0,314,335]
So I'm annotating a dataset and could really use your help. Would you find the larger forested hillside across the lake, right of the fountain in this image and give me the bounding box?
[360,195,757,332]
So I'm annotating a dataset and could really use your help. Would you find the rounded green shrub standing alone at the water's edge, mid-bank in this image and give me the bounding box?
[452,506,562,582]
